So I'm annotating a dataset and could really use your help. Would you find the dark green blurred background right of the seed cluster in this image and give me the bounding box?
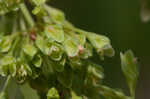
[51,0,150,99]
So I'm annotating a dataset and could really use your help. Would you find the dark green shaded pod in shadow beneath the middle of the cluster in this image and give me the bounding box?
[57,66,73,88]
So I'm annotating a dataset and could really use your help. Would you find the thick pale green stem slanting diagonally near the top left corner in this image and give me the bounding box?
[20,3,35,28]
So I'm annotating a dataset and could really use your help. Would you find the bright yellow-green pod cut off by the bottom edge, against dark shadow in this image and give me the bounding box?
[47,88,60,99]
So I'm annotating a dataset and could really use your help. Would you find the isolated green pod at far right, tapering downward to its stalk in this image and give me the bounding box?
[120,50,139,97]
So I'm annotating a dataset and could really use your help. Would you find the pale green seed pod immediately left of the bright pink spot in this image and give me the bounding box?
[64,38,79,57]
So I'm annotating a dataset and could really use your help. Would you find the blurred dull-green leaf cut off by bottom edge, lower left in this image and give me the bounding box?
[20,83,40,99]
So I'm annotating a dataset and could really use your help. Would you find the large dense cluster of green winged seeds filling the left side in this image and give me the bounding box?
[0,0,138,99]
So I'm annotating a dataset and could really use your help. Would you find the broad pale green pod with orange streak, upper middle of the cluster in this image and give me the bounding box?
[45,25,64,42]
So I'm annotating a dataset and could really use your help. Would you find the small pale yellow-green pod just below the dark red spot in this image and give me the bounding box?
[23,43,37,59]
